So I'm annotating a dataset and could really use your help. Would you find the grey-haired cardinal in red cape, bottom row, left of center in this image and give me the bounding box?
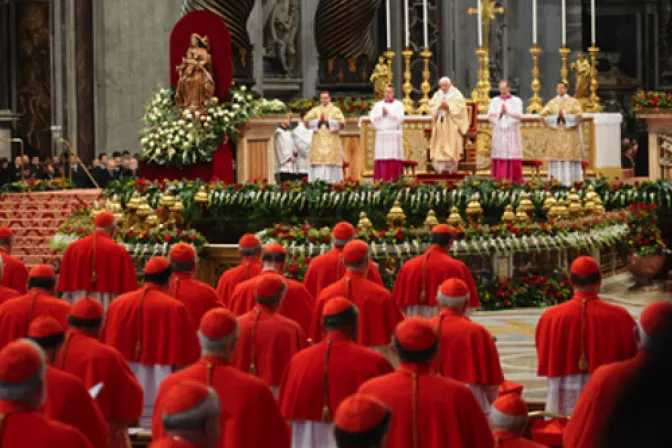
[152,308,290,448]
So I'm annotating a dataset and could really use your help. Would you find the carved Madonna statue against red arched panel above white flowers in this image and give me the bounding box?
[175,33,215,110]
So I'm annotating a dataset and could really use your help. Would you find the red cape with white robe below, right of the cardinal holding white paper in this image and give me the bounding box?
[101,283,200,366]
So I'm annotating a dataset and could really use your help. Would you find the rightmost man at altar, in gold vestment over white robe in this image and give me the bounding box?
[539,82,584,187]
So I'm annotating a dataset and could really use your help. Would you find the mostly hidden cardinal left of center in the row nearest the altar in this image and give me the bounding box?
[217,233,261,308]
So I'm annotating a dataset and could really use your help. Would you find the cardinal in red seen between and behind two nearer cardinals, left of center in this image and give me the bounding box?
[233,272,308,396]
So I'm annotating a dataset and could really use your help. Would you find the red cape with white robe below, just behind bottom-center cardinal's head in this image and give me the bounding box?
[278,332,394,422]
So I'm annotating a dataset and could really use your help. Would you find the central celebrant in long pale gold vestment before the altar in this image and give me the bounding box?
[429,77,469,173]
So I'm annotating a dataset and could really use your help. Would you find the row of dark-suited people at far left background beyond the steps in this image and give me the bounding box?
[0,151,140,188]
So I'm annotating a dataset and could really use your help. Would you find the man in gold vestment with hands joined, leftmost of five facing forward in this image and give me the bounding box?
[303,91,345,182]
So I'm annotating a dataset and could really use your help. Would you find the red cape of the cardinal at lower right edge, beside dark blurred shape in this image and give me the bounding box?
[563,351,647,448]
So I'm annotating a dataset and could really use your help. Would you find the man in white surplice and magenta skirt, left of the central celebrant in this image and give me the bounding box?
[370,84,405,182]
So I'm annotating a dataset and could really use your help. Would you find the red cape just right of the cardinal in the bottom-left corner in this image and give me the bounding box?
[43,367,107,448]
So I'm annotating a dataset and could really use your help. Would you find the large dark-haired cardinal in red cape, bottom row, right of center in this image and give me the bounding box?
[359,317,493,448]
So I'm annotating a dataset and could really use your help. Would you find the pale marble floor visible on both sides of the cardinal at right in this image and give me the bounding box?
[472,273,672,402]
